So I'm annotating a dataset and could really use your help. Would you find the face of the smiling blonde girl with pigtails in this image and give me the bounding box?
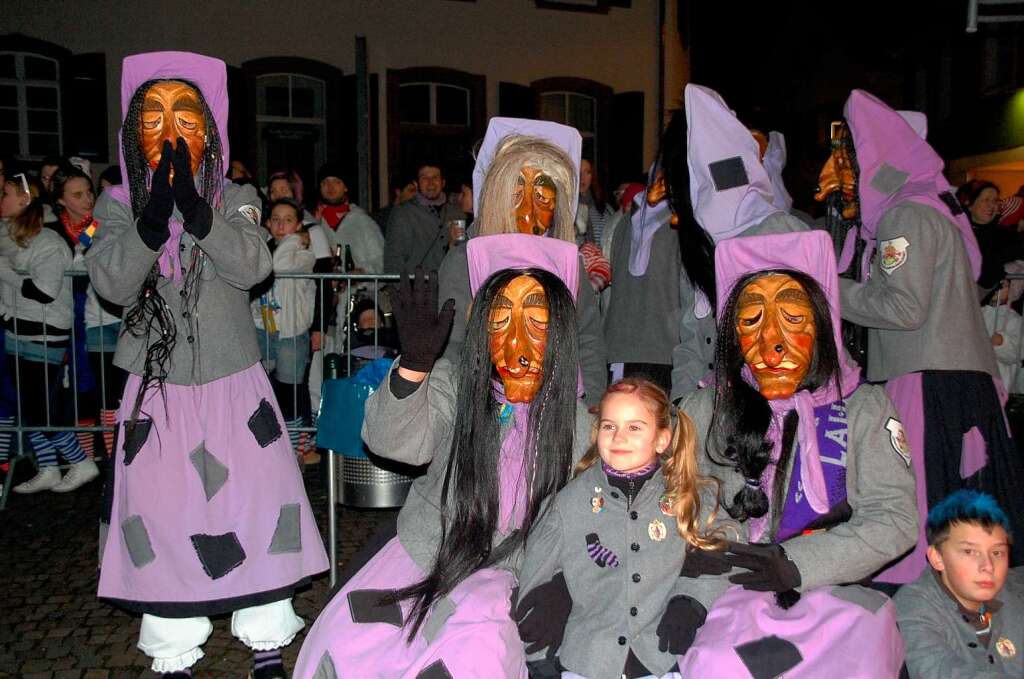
[597,393,672,472]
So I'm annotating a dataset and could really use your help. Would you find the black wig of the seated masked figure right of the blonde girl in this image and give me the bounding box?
[705,269,842,535]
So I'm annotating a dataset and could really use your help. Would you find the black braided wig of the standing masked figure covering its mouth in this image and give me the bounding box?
[121,79,224,426]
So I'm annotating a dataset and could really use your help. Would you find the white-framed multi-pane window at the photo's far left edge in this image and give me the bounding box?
[0,52,63,160]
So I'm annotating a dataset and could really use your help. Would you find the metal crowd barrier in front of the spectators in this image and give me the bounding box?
[0,270,403,586]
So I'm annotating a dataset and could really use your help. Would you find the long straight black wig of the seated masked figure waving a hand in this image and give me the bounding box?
[392,268,580,639]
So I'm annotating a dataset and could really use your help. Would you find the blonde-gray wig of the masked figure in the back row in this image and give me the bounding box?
[477,134,579,243]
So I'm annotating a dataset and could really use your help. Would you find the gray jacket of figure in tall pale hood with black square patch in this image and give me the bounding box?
[672,211,810,401]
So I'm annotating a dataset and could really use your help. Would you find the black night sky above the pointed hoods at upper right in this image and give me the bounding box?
[682,0,977,209]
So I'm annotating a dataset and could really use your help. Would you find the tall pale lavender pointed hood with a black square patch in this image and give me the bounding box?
[684,84,780,244]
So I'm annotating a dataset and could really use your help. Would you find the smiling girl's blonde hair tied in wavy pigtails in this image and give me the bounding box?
[574,377,725,549]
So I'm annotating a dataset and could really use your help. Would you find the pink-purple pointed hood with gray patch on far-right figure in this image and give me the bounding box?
[844,89,981,280]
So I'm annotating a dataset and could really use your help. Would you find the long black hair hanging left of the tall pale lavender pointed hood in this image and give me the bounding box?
[658,109,716,308]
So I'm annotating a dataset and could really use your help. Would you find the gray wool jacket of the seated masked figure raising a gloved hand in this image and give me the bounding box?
[362,358,593,574]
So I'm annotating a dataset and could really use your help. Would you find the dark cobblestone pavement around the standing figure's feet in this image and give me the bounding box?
[0,458,393,679]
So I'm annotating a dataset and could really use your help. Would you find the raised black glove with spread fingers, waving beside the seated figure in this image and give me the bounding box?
[393,266,455,373]
